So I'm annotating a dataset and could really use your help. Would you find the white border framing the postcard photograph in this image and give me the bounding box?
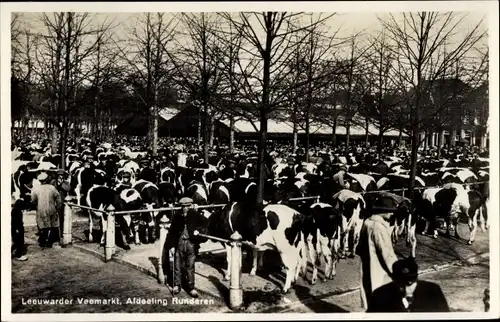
[0,1,500,321]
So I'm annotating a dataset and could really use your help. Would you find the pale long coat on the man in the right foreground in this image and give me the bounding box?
[358,215,398,309]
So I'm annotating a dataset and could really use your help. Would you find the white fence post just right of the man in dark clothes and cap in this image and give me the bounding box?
[229,232,243,310]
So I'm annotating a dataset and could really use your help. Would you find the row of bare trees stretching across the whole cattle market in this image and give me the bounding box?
[11,12,488,201]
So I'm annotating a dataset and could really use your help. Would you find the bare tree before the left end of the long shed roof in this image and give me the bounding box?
[119,13,178,156]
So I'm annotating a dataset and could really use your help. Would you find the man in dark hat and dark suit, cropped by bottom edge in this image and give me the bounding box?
[367,258,450,313]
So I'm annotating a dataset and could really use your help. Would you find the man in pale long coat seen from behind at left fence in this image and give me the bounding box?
[31,172,62,247]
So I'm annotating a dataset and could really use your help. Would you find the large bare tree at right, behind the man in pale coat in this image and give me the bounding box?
[380,12,485,198]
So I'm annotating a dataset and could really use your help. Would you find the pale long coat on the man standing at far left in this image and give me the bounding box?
[31,184,62,229]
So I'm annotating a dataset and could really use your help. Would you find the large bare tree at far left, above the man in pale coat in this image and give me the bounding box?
[16,12,111,168]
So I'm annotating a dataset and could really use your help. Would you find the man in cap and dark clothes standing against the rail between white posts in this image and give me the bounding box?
[163,197,206,297]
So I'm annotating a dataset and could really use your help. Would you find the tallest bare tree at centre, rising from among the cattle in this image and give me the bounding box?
[221,12,334,204]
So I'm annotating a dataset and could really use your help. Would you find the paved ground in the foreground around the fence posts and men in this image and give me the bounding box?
[13,210,489,312]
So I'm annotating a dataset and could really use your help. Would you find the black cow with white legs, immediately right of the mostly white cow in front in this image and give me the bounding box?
[304,203,342,284]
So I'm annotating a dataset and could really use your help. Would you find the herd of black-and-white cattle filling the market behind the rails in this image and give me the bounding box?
[12,144,489,292]
